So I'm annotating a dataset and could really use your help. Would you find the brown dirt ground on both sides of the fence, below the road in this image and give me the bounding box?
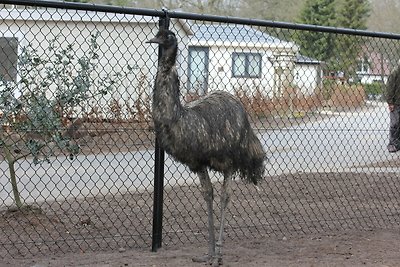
[0,173,400,267]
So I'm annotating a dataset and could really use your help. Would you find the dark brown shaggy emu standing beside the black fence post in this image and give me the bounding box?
[147,29,266,266]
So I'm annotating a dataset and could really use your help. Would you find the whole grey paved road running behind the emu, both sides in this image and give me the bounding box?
[0,103,397,206]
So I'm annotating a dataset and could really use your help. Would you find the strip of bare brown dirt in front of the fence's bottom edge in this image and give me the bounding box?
[2,229,400,267]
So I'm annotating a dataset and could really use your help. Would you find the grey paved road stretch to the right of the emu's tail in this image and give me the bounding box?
[263,103,398,174]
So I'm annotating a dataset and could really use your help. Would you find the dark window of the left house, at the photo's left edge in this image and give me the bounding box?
[0,37,18,81]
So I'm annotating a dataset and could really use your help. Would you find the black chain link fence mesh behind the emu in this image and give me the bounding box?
[0,1,400,262]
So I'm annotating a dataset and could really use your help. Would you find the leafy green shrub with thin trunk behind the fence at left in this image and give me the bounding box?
[0,34,127,208]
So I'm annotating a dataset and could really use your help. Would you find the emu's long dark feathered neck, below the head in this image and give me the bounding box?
[153,47,182,125]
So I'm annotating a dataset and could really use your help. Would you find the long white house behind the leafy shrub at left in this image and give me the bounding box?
[0,8,191,119]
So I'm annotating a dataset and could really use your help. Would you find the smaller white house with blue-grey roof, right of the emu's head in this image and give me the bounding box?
[187,24,321,97]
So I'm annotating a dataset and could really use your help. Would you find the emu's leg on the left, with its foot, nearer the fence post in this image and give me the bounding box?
[193,169,215,262]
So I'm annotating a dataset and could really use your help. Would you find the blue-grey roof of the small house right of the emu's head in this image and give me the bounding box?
[191,24,296,48]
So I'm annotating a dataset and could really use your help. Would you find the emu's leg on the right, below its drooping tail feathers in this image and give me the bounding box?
[213,174,232,266]
